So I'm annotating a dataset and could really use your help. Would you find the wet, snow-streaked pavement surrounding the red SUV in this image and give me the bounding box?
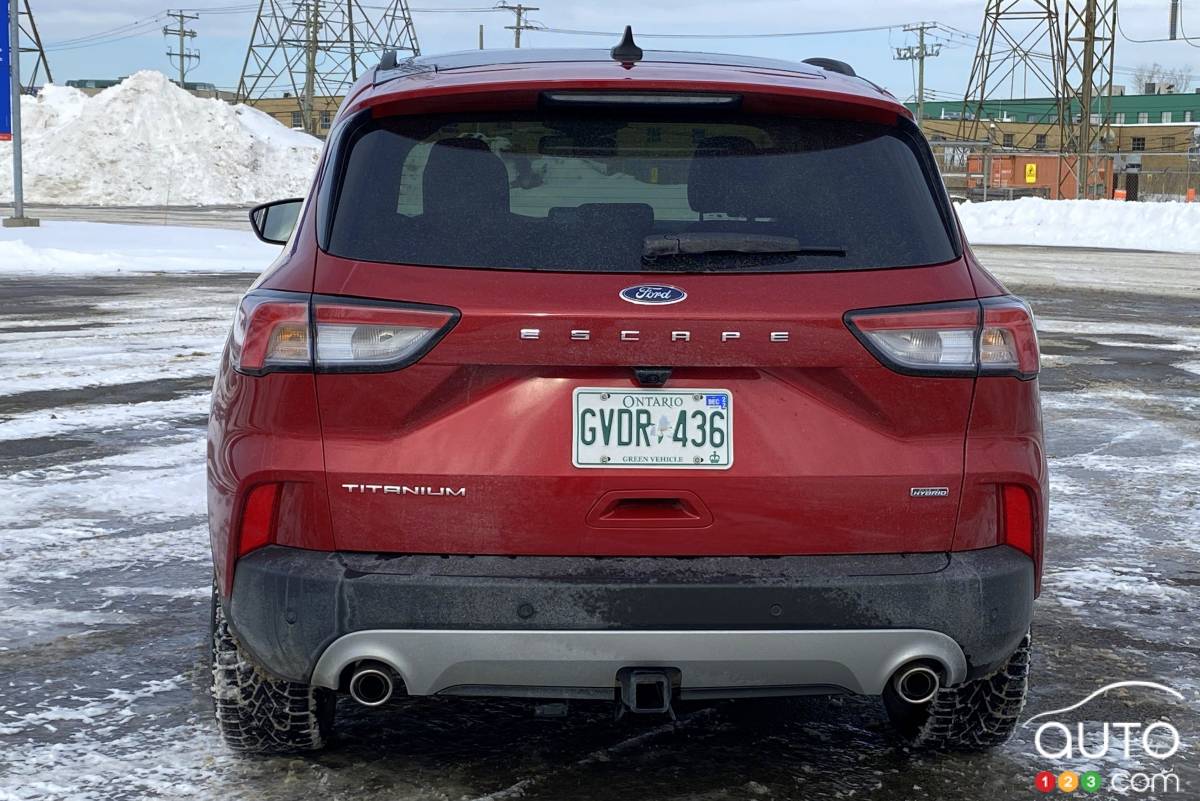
[0,248,1200,801]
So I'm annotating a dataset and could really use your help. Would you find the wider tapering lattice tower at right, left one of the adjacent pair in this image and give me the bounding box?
[959,0,1066,153]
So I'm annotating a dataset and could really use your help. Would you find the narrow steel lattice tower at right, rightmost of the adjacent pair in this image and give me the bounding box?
[1063,0,1117,198]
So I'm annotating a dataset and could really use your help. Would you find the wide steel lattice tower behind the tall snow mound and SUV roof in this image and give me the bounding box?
[238,0,421,133]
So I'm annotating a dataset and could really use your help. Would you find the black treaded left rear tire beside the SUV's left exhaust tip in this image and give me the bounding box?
[211,589,337,754]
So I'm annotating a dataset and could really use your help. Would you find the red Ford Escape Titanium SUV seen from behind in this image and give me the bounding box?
[208,37,1046,751]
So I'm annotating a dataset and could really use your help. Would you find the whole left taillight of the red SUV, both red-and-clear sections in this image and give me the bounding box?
[229,290,458,375]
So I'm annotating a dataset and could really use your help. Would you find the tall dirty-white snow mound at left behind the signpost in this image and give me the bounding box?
[0,71,322,206]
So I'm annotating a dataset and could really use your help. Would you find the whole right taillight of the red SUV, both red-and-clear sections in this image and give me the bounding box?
[846,296,1038,379]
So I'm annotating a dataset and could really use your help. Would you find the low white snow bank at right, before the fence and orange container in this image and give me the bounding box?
[958,198,1200,253]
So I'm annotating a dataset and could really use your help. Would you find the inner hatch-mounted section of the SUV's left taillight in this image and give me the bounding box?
[313,296,458,372]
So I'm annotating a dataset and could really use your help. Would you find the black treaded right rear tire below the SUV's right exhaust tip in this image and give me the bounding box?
[883,633,1030,751]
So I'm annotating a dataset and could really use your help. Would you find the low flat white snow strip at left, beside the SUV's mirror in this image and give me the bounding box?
[0,221,280,276]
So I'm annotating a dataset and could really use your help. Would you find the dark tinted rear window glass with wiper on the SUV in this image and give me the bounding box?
[328,112,955,272]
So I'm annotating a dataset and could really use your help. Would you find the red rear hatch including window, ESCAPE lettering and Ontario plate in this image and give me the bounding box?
[314,98,974,555]
